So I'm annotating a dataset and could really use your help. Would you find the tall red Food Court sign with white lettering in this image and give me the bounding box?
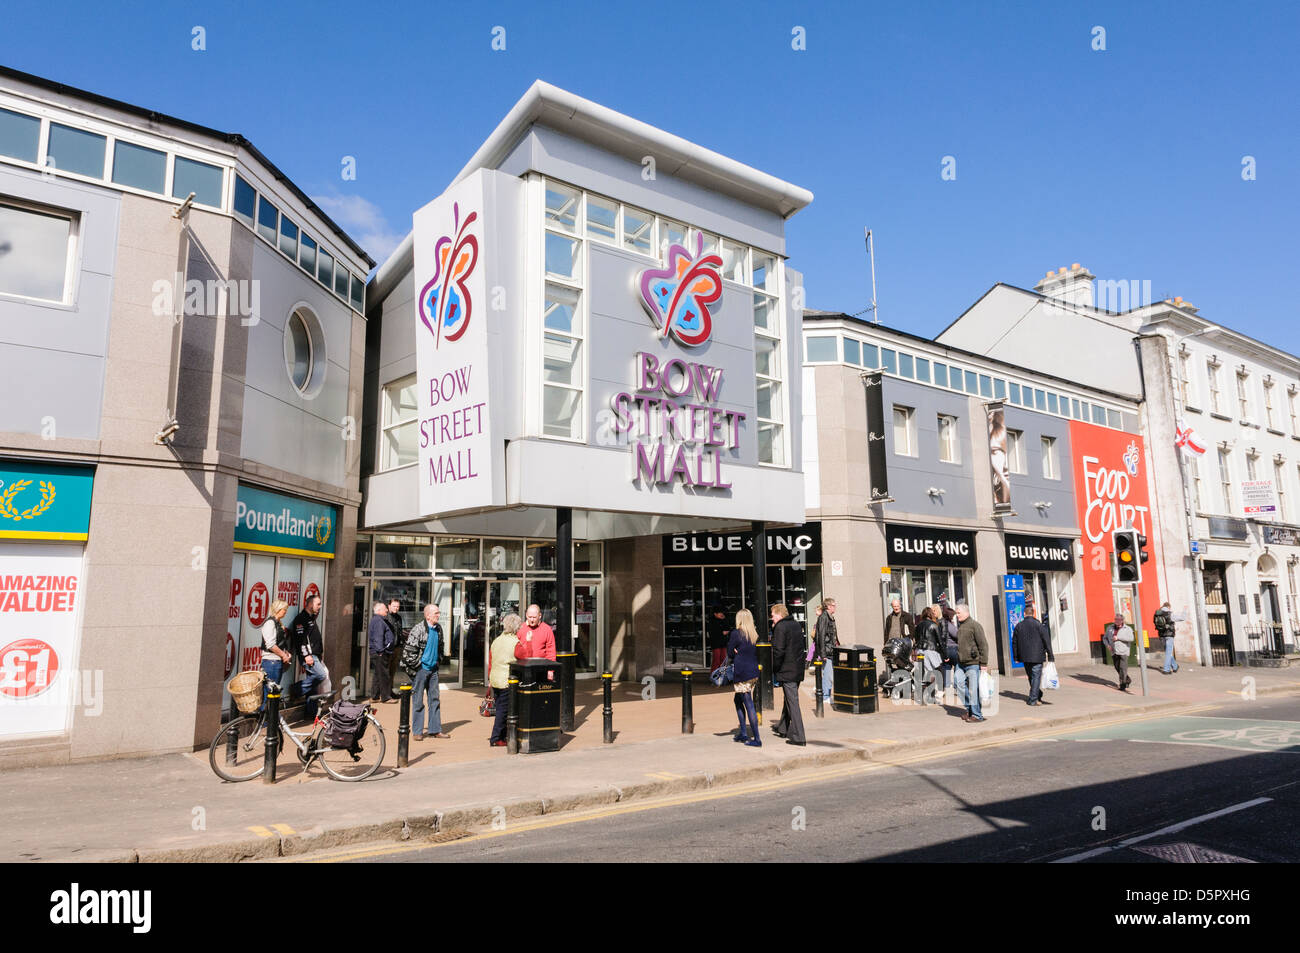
[1070,420,1162,642]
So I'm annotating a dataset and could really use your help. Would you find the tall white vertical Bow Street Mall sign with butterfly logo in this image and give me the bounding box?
[412,169,519,515]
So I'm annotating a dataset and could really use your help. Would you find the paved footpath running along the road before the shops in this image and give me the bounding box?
[0,663,1300,862]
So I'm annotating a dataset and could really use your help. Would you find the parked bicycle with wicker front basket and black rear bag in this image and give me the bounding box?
[208,692,386,781]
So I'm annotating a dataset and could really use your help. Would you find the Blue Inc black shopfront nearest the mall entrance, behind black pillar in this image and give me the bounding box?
[663,523,822,666]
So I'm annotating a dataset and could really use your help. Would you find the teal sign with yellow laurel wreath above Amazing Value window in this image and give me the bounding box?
[0,459,95,542]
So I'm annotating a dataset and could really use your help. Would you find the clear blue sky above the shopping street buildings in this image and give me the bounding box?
[0,0,1300,345]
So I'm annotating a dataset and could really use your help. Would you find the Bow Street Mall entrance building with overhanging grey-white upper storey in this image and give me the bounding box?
[356,83,811,684]
